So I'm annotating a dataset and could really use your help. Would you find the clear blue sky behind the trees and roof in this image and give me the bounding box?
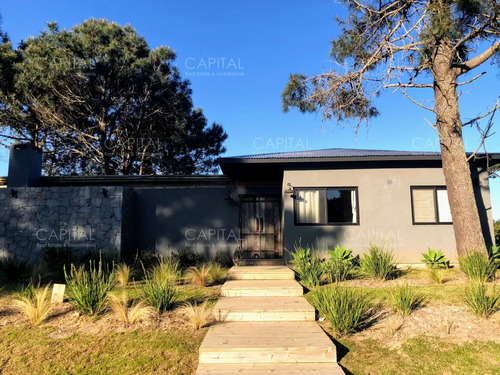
[0,0,500,219]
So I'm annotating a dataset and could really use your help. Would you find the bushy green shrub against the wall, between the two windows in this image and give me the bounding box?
[360,244,395,280]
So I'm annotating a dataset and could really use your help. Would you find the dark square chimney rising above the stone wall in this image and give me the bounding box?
[7,143,42,187]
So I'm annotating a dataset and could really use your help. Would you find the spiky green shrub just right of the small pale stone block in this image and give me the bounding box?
[64,261,115,315]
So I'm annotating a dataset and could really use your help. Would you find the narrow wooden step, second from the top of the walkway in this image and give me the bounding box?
[222,280,304,297]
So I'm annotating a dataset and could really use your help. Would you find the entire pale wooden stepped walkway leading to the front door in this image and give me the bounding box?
[196,265,344,375]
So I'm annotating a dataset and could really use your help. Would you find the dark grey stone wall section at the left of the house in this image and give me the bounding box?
[0,186,133,263]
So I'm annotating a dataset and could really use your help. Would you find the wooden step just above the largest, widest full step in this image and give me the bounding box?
[213,297,315,322]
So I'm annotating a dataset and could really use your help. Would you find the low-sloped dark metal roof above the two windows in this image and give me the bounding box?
[219,148,500,163]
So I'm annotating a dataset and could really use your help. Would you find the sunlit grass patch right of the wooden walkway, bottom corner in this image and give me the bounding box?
[337,337,500,375]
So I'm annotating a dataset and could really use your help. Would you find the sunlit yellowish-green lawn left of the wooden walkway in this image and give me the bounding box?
[0,327,206,375]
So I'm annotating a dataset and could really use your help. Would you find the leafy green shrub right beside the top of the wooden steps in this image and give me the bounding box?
[290,245,326,288]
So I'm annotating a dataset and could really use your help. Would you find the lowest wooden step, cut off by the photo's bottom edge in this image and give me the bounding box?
[196,363,345,375]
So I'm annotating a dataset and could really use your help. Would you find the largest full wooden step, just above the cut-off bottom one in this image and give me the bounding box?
[199,322,337,364]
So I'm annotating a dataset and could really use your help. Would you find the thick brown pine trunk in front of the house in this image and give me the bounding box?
[433,43,487,256]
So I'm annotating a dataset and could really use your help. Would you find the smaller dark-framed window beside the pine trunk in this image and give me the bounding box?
[411,186,451,224]
